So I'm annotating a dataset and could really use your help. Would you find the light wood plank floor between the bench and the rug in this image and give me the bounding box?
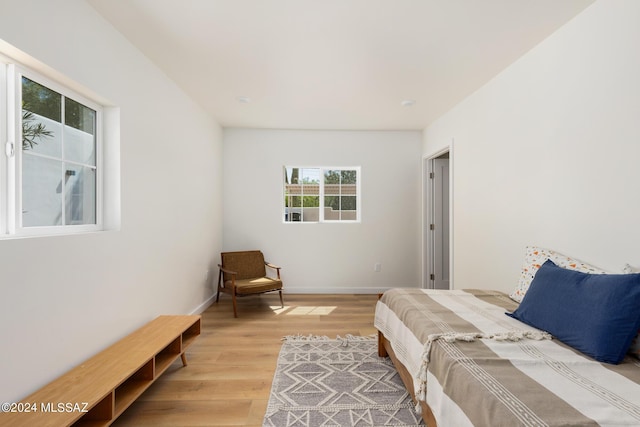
[113,293,378,427]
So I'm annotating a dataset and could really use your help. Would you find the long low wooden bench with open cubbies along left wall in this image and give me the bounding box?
[0,316,200,427]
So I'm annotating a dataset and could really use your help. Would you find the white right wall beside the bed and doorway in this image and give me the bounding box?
[423,0,640,291]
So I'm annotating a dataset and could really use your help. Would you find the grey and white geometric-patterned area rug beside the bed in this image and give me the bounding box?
[263,336,424,427]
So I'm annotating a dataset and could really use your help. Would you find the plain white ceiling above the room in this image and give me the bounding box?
[87,0,594,130]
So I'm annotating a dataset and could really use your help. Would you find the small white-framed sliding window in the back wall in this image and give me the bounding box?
[284,166,360,222]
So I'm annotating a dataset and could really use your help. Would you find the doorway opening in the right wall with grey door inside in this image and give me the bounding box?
[423,149,451,289]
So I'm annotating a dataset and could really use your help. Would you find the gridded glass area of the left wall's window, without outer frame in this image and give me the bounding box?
[20,76,97,231]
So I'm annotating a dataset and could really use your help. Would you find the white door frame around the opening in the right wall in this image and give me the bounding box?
[422,144,455,289]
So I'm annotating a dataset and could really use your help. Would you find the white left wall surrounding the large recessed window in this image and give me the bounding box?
[0,0,222,402]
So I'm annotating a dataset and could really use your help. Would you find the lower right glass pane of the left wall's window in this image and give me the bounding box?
[64,163,96,225]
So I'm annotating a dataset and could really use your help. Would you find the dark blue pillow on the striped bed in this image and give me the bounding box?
[507,260,640,364]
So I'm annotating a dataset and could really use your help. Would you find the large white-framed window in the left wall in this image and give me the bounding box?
[0,58,102,236]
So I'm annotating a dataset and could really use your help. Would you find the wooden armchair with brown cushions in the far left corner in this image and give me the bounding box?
[216,251,284,317]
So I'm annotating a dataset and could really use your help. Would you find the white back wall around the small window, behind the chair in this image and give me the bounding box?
[223,129,421,294]
